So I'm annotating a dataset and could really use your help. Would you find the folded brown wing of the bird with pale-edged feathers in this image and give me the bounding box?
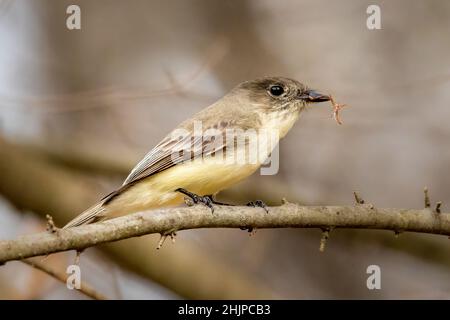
[123,121,234,186]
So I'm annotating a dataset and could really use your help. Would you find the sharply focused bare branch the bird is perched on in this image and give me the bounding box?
[0,203,450,263]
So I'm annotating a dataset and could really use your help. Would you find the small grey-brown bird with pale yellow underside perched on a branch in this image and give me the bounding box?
[63,77,330,228]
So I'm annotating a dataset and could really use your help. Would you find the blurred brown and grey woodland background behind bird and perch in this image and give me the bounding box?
[0,0,450,299]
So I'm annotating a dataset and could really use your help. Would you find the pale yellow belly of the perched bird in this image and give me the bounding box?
[105,159,260,218]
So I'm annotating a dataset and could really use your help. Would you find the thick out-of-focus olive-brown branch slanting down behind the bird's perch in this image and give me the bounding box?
[0,137,274,299]
